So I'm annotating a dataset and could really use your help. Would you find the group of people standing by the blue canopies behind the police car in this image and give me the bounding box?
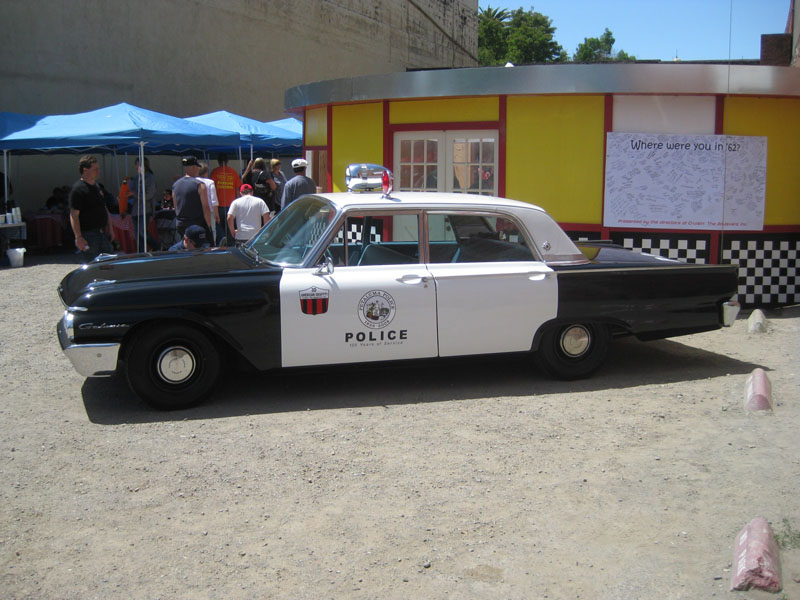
[66,154,316,262]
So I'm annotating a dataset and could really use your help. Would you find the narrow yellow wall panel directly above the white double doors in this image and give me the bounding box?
[389,96,500,125]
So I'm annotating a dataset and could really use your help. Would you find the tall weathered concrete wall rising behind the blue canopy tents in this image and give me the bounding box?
[0,0,478,210]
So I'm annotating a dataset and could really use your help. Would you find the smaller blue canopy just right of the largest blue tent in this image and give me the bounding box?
[186,110,303,159]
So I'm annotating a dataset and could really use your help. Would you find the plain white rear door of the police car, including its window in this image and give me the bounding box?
[427,211,558,356]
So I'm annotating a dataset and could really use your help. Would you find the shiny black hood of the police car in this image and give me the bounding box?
[58,248,256,306]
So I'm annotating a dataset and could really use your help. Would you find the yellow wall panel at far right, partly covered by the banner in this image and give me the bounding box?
[724,97,800,225]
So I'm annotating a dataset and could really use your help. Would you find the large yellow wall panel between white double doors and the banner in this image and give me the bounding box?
[506,96,605,225]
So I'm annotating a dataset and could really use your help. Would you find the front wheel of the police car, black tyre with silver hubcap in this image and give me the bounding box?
[127,325,220,410]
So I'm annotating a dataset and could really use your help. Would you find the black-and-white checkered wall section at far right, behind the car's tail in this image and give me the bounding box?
[721,235,800,306]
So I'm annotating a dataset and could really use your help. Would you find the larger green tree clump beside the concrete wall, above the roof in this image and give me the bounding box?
[478,6,567,66]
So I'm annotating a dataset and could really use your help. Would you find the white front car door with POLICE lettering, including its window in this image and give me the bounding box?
[281,213,437,367]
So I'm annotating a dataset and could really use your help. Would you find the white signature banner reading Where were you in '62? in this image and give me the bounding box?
[603,133,767,231]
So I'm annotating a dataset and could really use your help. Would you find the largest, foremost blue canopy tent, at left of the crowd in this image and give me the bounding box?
[0,103,239,251]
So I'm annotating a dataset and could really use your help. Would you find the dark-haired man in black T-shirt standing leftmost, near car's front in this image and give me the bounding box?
[69,156,114,262]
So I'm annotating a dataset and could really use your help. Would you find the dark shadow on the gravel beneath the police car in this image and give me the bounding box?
[82,338,769,425]
